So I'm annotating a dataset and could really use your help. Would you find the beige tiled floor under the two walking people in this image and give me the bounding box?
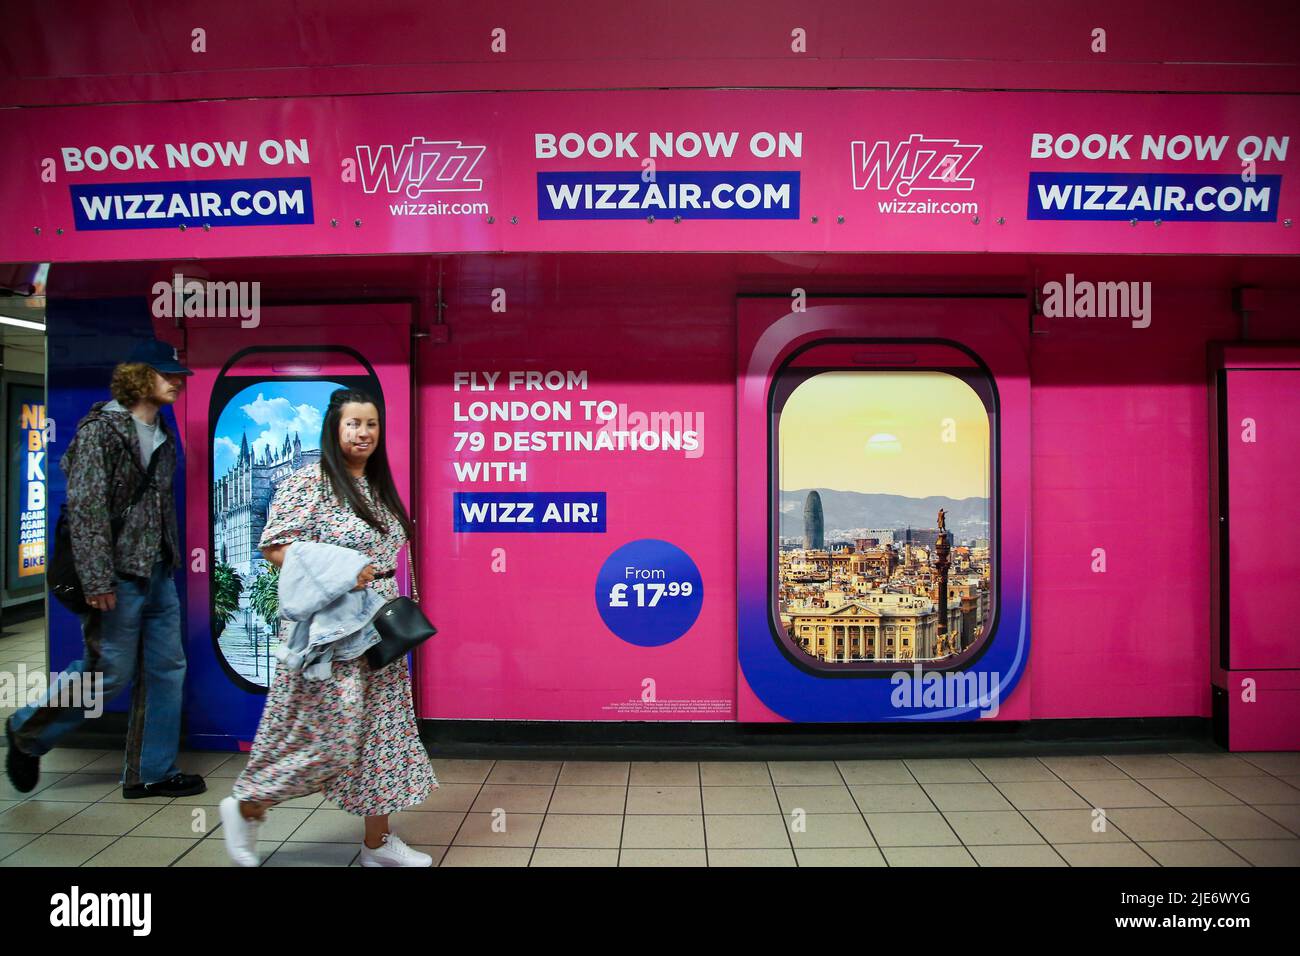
[0,622,1300,866]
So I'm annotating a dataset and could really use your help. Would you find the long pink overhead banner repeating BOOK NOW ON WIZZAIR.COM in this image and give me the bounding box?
[0,91,1300,261]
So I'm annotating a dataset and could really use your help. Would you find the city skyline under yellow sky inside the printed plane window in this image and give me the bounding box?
[774,371,992,667]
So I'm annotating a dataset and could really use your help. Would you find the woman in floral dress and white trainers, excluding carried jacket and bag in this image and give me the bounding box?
[221,389,438,866]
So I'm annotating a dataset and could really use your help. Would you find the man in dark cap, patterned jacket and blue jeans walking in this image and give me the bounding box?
[5,339,207,800]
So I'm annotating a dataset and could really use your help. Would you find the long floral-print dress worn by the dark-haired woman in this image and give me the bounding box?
[233,464,438,817]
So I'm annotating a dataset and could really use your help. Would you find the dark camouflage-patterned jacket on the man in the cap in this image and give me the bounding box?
[59,402,181,594]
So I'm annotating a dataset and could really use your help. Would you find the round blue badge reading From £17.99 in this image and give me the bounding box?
[595,537,705,648]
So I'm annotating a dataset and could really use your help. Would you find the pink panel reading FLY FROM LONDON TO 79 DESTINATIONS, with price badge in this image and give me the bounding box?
[416,310,737,721]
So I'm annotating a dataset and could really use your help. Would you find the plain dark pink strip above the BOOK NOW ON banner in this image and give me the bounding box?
[0,0,1300,107]
